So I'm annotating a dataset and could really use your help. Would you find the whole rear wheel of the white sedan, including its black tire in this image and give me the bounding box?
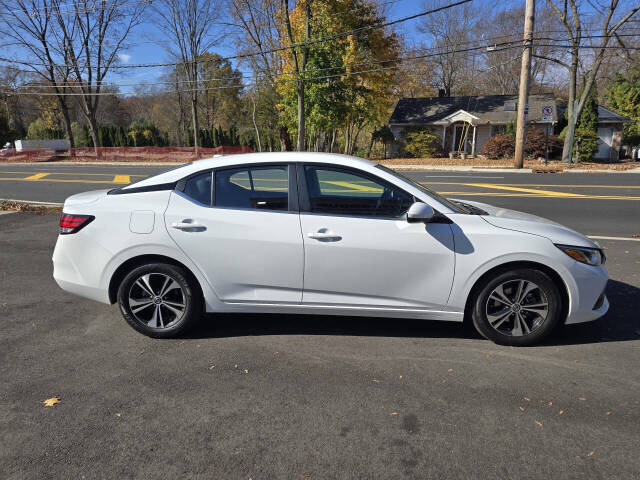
[118,263,203,338]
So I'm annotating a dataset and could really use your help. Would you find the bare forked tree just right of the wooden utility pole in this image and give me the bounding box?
[536,0,640,162]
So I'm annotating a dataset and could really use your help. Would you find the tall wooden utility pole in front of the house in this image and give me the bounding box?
[513,0,536,168]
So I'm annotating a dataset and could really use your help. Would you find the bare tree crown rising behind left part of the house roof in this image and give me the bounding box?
[418,0,478,96]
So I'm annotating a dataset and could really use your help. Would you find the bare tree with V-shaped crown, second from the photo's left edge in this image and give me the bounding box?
[52,0,147,158]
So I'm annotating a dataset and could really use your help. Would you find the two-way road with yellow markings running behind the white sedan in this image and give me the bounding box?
[0,164,640,237]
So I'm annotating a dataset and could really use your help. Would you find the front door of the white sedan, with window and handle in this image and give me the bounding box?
[298,164,454,309]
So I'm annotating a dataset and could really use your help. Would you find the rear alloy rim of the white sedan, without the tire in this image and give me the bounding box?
[128,273,186,329]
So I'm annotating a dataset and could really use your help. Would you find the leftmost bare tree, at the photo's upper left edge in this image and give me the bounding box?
[0,0,75,148]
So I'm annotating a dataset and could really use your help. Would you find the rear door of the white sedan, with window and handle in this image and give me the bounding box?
[165,165,304,303]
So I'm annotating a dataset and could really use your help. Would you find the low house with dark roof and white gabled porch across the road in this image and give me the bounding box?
[389,94,628,159]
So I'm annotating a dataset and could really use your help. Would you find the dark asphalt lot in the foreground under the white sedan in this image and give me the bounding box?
[0,212,640,480]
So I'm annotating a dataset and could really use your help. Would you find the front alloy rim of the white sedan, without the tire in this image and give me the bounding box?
[485,279,549,337]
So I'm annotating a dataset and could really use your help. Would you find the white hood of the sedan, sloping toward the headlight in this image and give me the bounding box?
[452,200,599,248]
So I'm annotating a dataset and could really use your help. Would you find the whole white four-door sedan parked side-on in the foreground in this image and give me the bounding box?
[53,153,609,345]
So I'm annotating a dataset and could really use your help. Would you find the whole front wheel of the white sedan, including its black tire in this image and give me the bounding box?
[472,269,563,347]
